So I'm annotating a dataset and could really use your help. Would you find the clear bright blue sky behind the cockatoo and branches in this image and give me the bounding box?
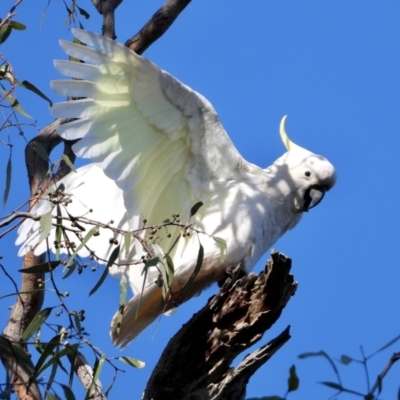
[0,0,400,399]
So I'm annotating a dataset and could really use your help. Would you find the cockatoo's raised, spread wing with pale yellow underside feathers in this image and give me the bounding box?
[52,29,259,224]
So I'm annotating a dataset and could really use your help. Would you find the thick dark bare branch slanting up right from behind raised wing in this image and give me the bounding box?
[125,0,190,54]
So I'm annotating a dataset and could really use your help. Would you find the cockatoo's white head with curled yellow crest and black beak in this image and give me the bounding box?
[275,116,336,212]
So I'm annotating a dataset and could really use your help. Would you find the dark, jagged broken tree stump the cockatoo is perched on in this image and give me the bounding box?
[143,251,297,400]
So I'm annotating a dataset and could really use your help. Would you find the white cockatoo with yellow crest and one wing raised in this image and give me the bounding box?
[17,29,336,347]
